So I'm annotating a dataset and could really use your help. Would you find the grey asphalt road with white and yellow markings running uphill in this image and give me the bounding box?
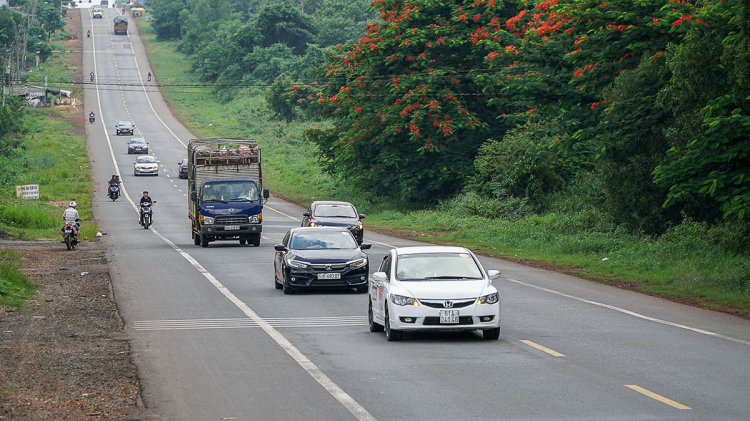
[81,9,750,420]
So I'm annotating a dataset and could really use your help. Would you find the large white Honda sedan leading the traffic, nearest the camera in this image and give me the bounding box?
[368,246,500,341]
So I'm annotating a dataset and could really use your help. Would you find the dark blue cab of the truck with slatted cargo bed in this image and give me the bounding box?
[196,178,269,247]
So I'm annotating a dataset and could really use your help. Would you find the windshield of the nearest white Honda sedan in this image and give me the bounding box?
[396,253,482,281]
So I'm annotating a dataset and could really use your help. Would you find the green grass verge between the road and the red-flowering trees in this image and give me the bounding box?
[138,20,750,313]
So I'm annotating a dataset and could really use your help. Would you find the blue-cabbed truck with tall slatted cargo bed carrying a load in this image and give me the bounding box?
[188,138,269,247]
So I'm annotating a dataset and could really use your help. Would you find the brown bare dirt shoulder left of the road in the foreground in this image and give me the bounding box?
[0,241,141,420]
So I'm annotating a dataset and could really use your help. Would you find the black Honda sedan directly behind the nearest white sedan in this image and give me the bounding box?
[273,227,370,294]
